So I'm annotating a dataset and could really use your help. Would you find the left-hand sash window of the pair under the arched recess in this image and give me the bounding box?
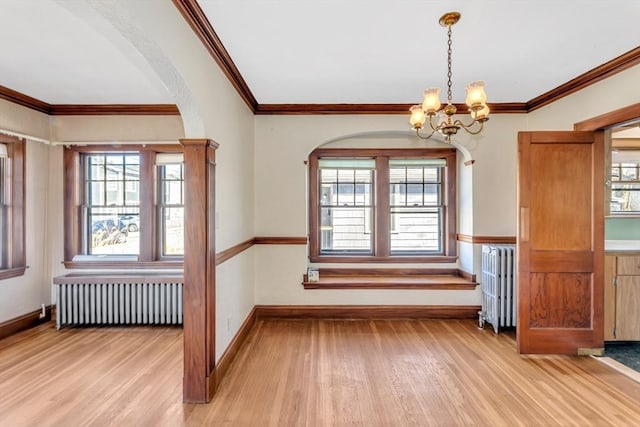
[318,159,375,254]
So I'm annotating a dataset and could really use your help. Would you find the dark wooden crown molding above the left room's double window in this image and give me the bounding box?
[48,104,180,116]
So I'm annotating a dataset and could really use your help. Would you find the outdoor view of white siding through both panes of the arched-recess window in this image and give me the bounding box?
[318,158,446,255]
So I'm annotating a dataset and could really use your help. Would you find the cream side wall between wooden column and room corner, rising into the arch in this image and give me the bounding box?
[101,2,255,359]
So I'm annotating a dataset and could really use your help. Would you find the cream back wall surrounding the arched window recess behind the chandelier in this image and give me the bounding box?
[256,115,526,305]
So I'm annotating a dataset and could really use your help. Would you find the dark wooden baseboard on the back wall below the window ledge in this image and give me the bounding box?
[255,305,481,320]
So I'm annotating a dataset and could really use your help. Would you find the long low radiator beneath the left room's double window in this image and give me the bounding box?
[54,276,182,329]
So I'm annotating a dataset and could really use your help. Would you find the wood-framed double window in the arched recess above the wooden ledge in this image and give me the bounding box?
[309,149,456,262]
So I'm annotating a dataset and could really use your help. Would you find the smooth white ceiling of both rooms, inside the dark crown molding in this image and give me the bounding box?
[0,0,640,104]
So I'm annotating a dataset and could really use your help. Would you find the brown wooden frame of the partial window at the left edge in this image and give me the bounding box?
[0,134,27,280]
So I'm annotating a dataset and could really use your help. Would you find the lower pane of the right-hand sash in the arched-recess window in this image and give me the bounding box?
[391,208,442,254]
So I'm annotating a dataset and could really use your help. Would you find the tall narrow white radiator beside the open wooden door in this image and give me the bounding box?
[478,245,517,333]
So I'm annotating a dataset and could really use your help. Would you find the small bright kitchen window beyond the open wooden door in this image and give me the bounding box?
[611,149,640,215]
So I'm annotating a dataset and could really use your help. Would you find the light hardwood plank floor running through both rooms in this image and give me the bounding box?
[0,320,640,427]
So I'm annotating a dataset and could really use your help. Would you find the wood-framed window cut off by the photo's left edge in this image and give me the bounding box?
[0,135,26,279]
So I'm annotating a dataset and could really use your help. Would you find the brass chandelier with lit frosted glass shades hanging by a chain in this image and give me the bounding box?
[409,12,489,143]
